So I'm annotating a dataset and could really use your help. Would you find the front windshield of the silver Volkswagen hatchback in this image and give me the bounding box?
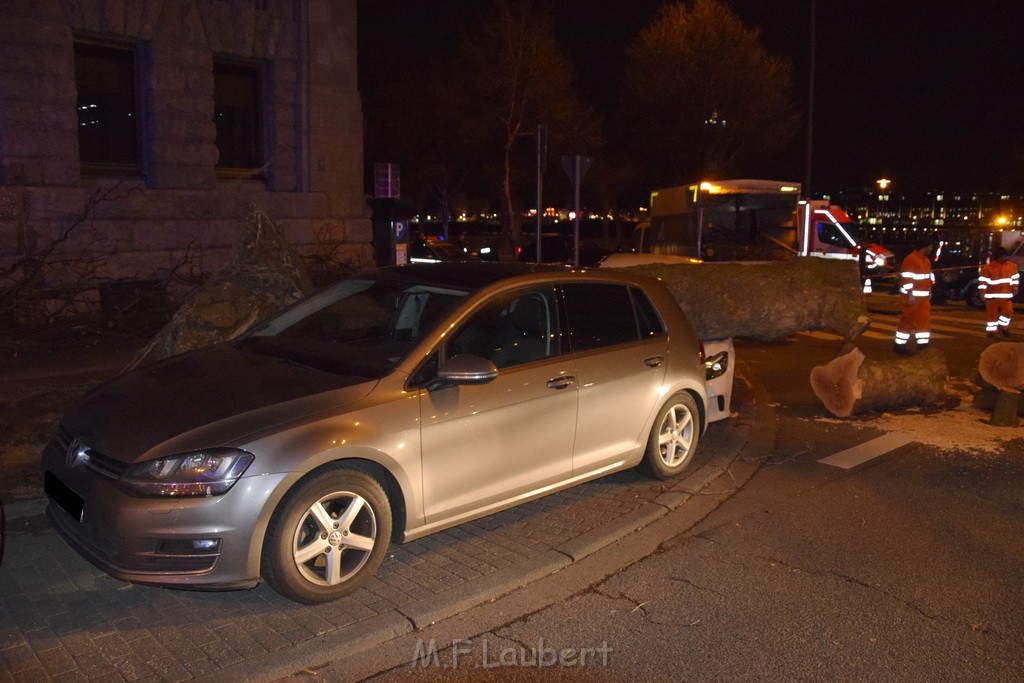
[237,274,468,379]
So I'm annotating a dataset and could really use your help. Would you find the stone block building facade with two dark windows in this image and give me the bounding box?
[0,0,373,309]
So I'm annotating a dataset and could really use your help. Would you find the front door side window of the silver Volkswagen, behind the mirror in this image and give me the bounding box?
[445,289,561,370]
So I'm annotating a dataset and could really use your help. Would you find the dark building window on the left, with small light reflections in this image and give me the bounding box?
[75,42,139,173]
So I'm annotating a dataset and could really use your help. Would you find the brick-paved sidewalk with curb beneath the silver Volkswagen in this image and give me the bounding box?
[0,350,753,682]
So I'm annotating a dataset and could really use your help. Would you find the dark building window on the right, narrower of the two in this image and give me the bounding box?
[213,61,263,175]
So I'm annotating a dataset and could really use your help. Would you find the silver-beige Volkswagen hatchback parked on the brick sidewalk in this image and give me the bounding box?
[42,262,710,603]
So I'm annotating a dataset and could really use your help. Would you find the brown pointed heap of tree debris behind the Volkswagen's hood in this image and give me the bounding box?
[129,205,313,369]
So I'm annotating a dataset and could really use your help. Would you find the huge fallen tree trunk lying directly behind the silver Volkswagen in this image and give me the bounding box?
[623,258,868,342]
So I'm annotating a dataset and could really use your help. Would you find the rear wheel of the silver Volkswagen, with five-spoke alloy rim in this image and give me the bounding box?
[643,391,700,479]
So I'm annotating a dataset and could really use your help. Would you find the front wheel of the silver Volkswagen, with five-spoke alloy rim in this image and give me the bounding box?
[261,467,391,604]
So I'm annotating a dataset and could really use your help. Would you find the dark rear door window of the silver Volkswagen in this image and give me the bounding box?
[564,284,639,351]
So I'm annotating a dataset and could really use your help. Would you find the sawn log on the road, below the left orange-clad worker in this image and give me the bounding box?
[811,348,947,418]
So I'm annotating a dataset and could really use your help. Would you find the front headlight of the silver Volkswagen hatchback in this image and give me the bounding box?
[121,449,253,497]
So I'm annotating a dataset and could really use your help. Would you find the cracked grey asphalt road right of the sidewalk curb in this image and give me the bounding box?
[297,297,1024,681]
